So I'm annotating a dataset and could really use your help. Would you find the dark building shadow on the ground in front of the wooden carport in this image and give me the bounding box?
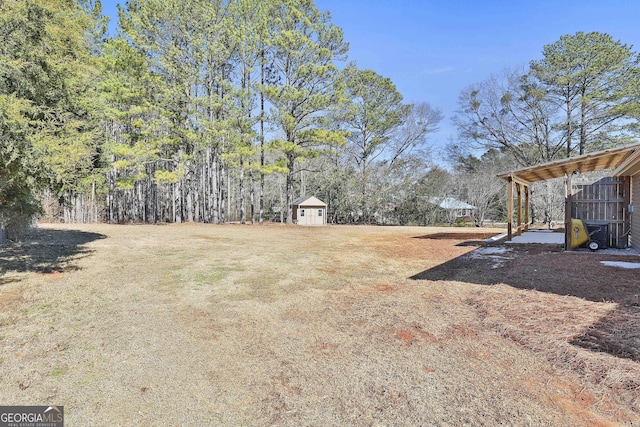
[411,244,640,362]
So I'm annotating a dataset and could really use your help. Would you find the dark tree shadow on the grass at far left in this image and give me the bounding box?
[0,228,106,285]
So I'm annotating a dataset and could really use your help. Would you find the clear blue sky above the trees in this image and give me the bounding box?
[97,0,640,160]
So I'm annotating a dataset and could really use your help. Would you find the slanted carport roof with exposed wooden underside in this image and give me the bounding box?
[498,144,640,182]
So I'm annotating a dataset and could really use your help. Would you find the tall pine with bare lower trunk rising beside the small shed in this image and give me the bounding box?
[263,0,348,223]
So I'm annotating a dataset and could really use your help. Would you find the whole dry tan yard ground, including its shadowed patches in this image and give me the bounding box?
[0,225,640,426]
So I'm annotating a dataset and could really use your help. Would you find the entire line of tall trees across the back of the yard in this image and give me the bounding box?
[0,0,639,238]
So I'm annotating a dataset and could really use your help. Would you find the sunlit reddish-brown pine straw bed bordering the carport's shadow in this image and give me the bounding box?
[470,285,640,419]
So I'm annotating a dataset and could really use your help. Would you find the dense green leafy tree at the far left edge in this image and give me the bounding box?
[0,0,99,241]
